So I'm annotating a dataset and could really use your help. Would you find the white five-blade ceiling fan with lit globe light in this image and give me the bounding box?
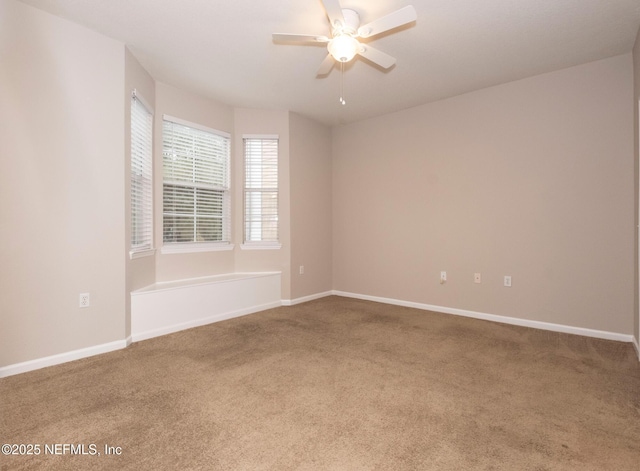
[273,0,417,76]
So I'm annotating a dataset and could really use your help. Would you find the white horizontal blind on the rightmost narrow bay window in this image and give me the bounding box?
[243,138,279,243]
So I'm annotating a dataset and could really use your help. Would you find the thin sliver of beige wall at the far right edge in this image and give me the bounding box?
[633,30,640,344]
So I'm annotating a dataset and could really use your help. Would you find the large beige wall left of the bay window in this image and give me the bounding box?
[0,0,125,366]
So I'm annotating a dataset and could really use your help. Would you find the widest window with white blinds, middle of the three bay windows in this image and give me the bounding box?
[162,116,232,252]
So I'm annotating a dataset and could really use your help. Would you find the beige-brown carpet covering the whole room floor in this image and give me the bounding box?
[0,297,640,471]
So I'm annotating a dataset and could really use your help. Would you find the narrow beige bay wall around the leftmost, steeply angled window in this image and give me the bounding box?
[124,49,156,337]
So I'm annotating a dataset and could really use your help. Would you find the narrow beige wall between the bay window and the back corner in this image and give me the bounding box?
[290,113,332,299]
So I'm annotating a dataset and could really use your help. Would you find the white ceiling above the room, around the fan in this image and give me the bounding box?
[15,0,640,125]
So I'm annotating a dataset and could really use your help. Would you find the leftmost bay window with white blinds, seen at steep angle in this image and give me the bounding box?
[130,90,153,258]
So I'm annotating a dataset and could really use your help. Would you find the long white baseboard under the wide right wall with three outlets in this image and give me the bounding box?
[333,290,638,348]
